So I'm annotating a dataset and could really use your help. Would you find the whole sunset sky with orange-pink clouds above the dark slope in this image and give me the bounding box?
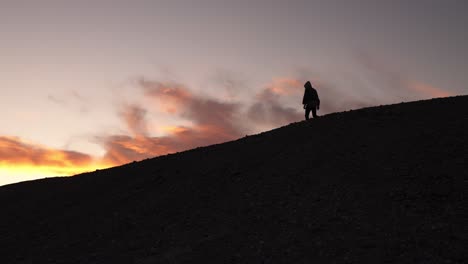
[0,0,468,185]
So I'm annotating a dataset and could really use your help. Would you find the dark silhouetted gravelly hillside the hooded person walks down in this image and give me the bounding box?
[0,96,468,263]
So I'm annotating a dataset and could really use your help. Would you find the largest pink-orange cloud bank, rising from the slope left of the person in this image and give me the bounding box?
[98,80,242,164]
